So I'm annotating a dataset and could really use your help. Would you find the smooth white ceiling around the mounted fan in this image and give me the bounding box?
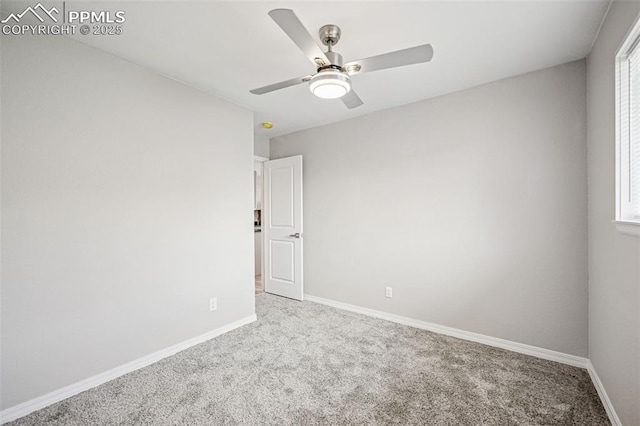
[2,0,609,137]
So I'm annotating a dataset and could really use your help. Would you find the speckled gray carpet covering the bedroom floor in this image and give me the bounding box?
[11,294,609,426]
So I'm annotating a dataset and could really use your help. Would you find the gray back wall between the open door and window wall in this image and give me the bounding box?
[271,61,587,356]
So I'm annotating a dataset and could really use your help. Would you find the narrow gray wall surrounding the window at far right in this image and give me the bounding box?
[587,1,640,426]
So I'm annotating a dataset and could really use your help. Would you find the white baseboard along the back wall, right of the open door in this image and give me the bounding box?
[304,294,588,368]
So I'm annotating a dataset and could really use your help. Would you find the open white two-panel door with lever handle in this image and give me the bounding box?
[262,155,303,300]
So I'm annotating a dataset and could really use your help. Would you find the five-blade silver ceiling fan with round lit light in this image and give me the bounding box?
[250,9,433,109]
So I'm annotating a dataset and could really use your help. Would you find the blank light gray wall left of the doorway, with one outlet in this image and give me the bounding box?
[1,36,254,408]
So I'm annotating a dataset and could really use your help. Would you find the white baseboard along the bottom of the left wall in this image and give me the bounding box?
[0,314,258,424]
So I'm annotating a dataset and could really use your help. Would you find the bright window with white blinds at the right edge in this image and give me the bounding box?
[616,21,640,236]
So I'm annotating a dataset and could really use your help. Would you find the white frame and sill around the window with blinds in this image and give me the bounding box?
[613,18,640,237]
